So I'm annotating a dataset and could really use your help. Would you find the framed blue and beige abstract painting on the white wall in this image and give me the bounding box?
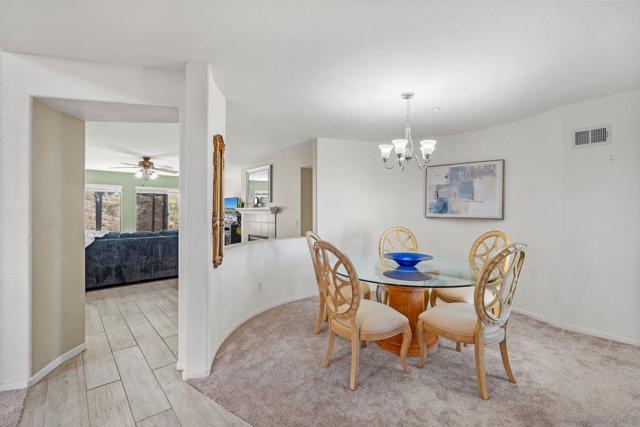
[426,159,504,219]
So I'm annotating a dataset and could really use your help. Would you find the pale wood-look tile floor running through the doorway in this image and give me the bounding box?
[19,279,248,427]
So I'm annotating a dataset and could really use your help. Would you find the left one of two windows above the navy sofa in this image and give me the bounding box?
[84,185,122,231]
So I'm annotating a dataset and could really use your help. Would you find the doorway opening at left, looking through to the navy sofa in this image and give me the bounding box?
[31,98,180,385]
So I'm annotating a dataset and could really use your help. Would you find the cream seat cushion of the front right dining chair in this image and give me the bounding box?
[419,302,504,344]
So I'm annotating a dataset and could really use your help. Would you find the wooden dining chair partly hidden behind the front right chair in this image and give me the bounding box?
[430,231,509,310]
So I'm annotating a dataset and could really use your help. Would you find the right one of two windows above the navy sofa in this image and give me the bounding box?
[136,187,180,231]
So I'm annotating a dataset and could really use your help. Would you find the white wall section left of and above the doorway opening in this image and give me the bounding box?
[0,52,184,389]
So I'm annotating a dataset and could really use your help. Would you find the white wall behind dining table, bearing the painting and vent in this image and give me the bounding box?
[316,91,640,343]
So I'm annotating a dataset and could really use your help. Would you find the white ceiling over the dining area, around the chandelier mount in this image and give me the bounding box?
[0,0,640,161]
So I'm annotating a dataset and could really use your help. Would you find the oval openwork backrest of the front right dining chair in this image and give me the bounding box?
[474,243,527,326]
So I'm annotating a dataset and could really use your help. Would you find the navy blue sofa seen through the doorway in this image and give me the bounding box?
[85,230,178,289]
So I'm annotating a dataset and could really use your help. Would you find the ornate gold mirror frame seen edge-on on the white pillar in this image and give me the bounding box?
[211,135,224,268]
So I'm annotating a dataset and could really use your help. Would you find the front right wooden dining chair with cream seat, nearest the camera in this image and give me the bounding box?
[416,243,527,400]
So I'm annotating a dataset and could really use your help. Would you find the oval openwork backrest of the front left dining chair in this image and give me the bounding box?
[314,240,360,320]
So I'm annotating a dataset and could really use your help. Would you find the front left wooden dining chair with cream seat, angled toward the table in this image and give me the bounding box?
[314,240,411,390]
